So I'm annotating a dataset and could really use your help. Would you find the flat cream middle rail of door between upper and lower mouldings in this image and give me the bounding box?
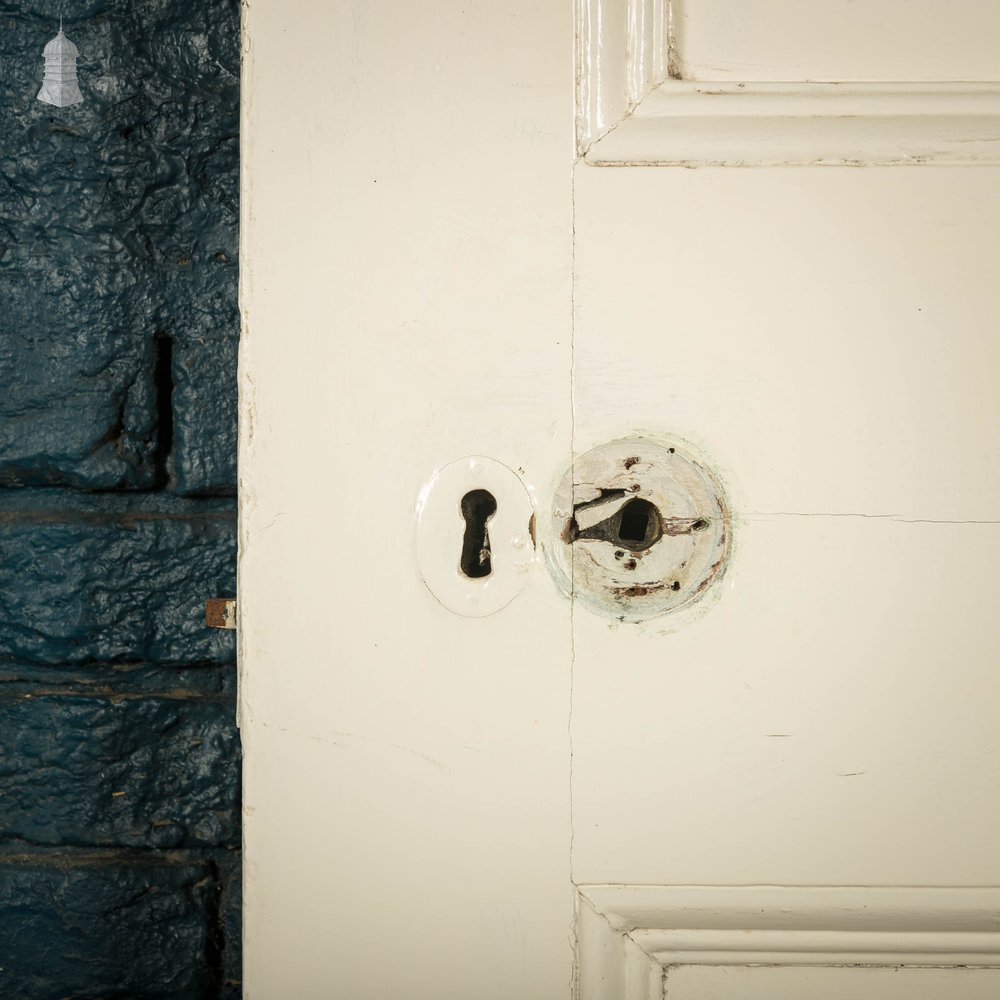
[572,165,1000,984]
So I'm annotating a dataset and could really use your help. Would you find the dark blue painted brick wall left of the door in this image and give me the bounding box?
[0,0,240,1000]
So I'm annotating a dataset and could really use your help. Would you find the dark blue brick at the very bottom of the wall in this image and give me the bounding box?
[0,851,238,1000]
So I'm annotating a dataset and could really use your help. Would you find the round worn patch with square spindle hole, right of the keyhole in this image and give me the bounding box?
[545,437,732,622]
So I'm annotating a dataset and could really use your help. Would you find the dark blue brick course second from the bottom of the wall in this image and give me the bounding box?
[0,671,240,848]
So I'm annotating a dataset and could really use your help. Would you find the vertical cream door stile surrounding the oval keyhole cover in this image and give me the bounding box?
[239,0,574,1000]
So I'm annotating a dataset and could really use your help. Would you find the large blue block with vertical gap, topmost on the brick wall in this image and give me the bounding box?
[0,0,239,493]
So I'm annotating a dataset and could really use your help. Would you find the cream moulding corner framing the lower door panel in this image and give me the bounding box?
[577,885,1000,1000]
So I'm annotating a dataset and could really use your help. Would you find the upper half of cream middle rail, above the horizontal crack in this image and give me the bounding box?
[575,166,1000,524]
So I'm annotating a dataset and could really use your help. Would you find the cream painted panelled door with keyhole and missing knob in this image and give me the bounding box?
[239,0,1000,1000]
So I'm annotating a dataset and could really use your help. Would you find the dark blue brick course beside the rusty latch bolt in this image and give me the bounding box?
[0,490,236,664]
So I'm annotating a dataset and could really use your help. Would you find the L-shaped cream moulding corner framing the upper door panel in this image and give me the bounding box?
[576,0,1000,167]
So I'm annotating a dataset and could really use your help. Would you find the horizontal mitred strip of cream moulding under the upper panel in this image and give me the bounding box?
[583,80,1000,167]
